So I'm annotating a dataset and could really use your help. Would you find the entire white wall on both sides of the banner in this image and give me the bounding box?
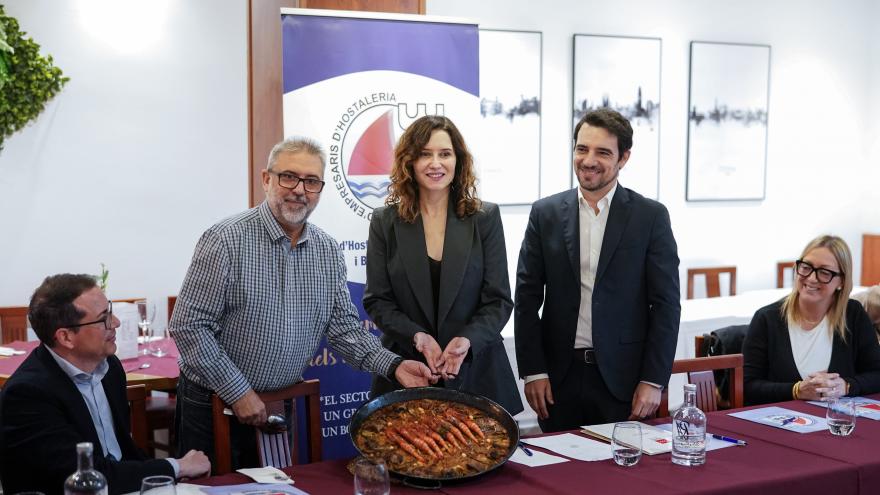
[0,0,880,326]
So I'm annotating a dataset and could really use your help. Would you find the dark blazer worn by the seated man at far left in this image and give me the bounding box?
[0,345,174,495]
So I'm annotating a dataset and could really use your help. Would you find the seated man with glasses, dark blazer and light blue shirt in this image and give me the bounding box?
[0,274,211,495]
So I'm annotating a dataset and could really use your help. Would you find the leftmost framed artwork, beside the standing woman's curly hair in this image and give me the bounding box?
[478,29,542,205]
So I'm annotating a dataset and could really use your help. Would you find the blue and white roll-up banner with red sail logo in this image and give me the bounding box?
[281,9,479,459]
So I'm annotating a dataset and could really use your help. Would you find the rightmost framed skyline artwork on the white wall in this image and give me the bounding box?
[685,41,770,201]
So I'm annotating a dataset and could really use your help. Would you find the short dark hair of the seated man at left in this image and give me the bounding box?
[28,273,98,347]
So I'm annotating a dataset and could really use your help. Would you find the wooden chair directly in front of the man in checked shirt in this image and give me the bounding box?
[212,380,322,474]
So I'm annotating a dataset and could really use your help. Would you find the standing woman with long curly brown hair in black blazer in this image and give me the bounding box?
[363,116,523,414]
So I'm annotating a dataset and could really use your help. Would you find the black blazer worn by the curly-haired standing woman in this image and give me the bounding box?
[364,202,523,414]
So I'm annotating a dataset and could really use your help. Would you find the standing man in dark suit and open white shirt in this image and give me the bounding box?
[514,108,681,431]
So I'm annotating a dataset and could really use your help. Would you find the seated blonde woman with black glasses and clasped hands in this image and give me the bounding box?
[743,236,880,404]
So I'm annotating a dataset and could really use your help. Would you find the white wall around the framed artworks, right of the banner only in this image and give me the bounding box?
[428,0,880,304]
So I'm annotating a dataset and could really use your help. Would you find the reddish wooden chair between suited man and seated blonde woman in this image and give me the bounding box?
[657,354,743,418]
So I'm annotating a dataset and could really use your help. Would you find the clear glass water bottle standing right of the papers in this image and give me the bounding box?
[672,383,706,466]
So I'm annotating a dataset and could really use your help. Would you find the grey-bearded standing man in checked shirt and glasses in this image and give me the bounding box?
[169,138,436,468]
